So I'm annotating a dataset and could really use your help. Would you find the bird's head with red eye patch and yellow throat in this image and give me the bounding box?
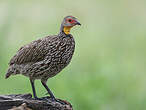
[61,16,81,35]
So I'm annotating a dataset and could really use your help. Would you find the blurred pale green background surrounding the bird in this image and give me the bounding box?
[0,0,146,110]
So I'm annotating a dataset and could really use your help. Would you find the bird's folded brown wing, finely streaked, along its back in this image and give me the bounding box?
[9,36,57,65]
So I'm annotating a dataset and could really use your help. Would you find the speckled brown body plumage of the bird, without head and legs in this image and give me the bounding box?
[7,35,75,80]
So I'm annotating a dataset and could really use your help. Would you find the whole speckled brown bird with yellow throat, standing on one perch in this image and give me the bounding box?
[5,16,81,100]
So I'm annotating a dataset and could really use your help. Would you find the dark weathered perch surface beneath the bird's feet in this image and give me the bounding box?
[0,94,73,110]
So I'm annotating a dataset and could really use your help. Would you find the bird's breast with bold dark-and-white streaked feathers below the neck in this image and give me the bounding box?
[47,38,75,68]
